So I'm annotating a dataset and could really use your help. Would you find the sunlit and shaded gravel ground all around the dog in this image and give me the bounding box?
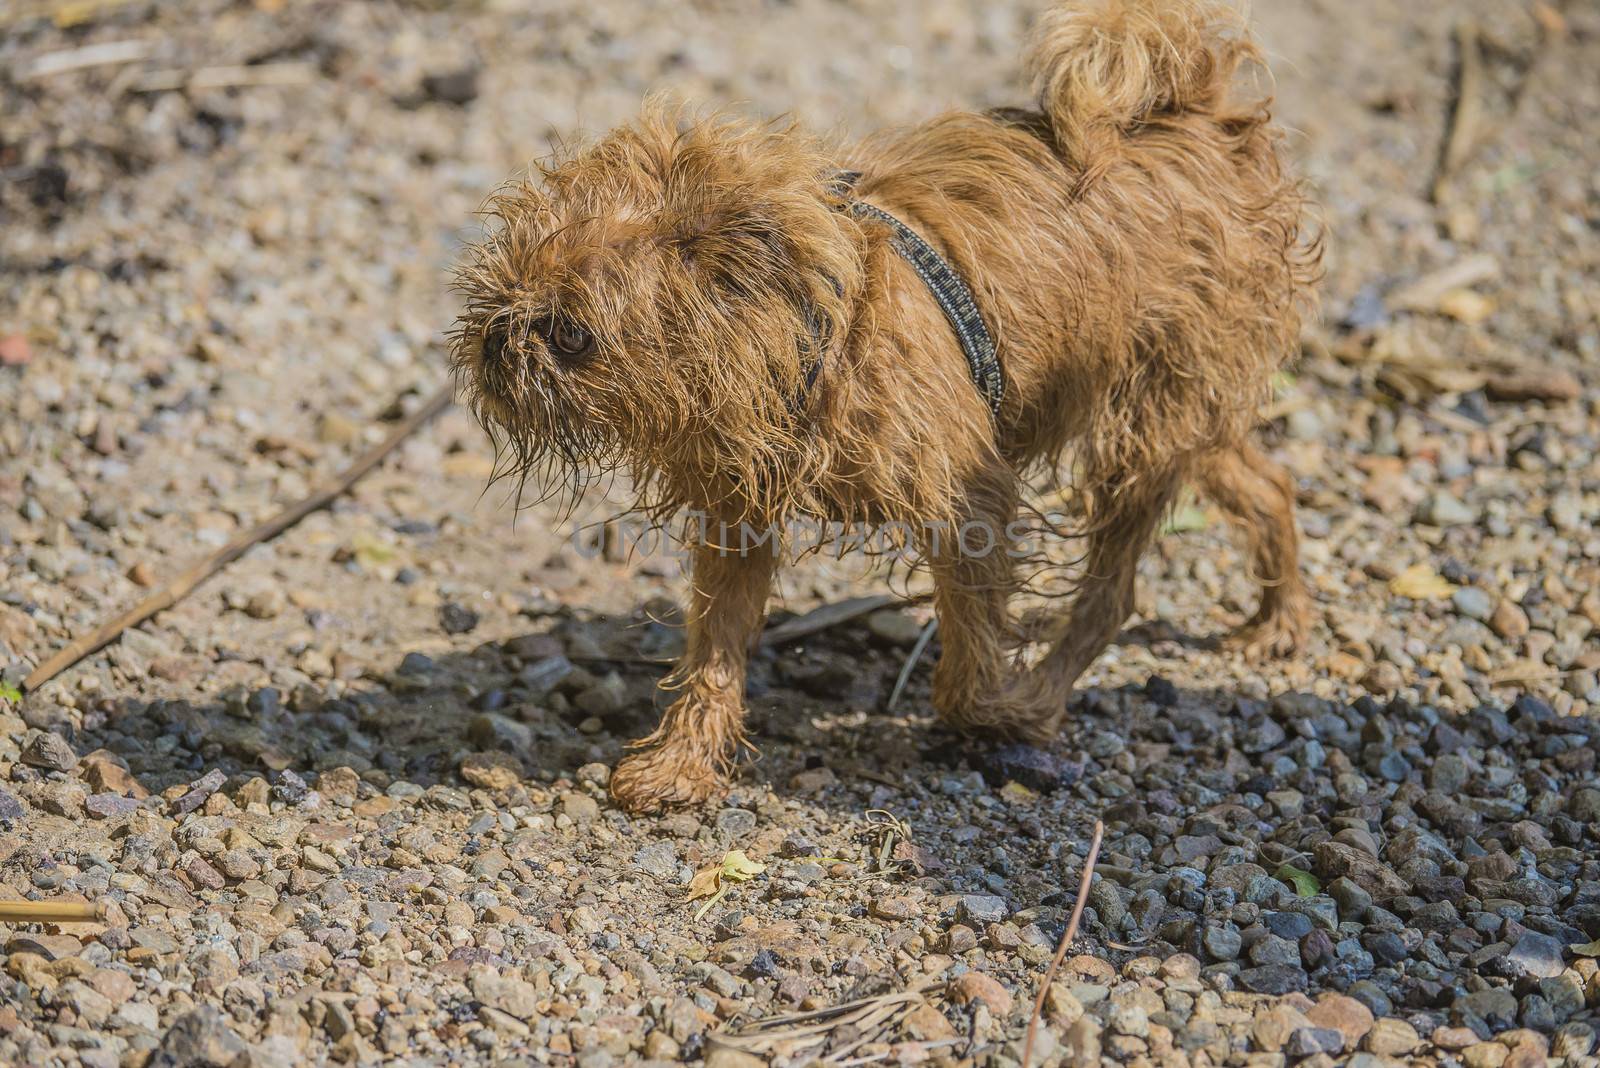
[0,0,1600,1068]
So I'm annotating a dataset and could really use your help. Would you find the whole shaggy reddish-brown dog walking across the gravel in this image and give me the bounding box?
[454,0,1318,811]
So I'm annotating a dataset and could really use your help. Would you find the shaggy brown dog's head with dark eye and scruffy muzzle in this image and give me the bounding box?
[451,106,859,507]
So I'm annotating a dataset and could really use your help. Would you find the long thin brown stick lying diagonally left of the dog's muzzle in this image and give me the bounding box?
[22,385,454,692]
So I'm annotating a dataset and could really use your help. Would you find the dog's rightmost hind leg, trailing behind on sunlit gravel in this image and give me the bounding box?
[1197,441,1310,656]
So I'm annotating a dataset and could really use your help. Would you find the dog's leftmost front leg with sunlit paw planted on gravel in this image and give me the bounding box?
[611,534,778,812]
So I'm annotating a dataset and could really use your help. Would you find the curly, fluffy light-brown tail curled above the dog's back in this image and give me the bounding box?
[1024,0,1258,177]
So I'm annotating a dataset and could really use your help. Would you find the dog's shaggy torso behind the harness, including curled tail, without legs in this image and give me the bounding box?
[858,0,1320,470]
